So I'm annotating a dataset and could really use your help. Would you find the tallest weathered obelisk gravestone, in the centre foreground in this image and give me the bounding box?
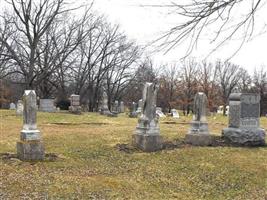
[133,83,162,152]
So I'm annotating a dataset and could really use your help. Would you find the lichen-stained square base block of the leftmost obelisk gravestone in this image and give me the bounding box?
[17,141,45,161]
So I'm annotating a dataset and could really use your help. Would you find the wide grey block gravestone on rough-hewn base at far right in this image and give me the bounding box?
[222,93,265,146]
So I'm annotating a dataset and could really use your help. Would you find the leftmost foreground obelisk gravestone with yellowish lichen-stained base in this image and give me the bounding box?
[17,90,45,161]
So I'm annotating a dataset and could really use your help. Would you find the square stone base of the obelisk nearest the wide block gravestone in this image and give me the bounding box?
[185,133,212,146]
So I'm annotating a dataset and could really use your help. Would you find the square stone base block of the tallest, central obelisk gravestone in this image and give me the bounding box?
[132,134,162,152]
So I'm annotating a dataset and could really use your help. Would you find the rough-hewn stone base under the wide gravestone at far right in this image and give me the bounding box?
[222,127,265,146]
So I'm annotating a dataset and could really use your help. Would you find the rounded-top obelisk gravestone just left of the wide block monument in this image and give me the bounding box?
[185,92,212,146]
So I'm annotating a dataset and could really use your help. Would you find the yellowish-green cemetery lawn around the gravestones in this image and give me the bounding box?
[0,110,267,200]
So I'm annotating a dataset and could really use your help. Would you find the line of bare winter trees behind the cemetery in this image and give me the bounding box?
[0,0,267,114]
